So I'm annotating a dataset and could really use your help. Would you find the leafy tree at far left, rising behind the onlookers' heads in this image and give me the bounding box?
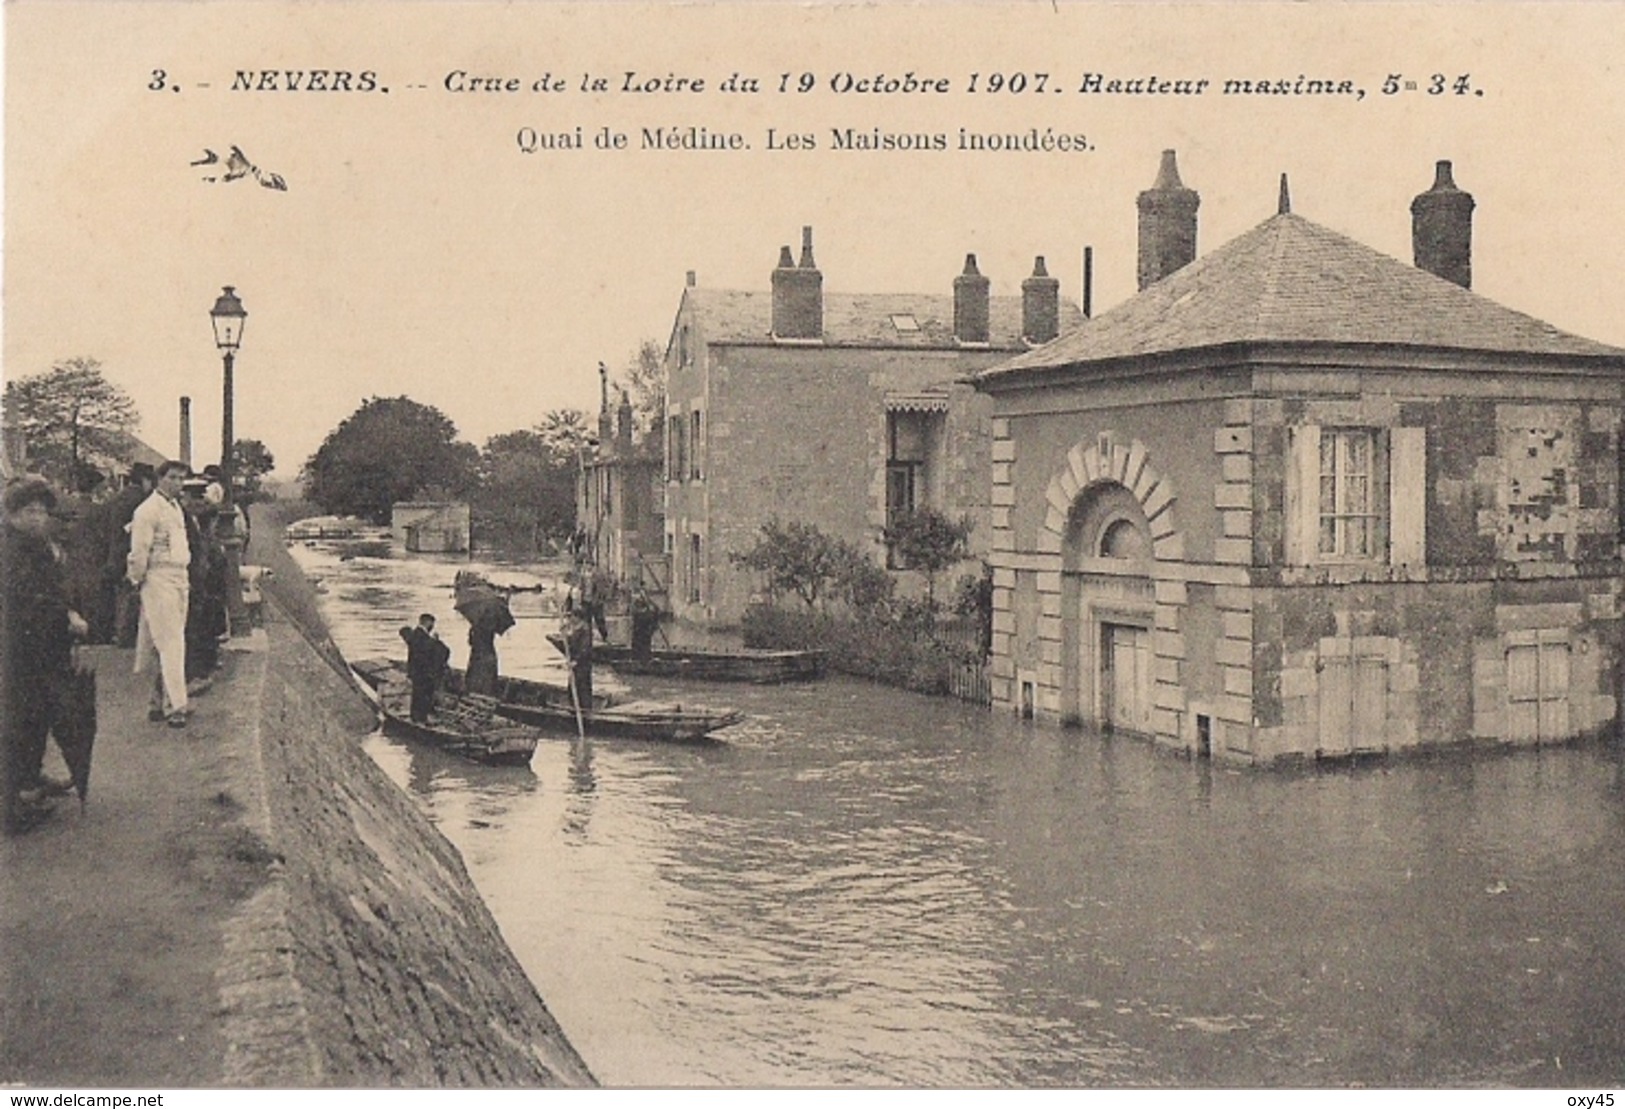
[5,356,140,488]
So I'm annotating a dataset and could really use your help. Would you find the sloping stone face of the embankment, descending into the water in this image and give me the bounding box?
[232,513,593,1086]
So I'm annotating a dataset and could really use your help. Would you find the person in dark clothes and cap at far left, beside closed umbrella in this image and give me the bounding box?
[0,475,89,834]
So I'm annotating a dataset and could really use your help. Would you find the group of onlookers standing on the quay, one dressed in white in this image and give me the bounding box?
[0,462,241,834]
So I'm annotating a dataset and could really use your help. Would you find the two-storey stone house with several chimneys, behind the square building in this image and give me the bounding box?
[665,228,1081,628]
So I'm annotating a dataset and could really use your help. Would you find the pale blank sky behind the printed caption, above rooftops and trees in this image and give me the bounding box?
[3,0,1625,478]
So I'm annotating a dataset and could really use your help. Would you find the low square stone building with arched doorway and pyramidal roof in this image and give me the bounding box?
[978,151,1625,763]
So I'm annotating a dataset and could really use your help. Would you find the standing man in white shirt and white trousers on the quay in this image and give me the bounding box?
[127,462,192,728]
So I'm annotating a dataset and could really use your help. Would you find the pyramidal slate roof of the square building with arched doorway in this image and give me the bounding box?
[978,213,1625,381]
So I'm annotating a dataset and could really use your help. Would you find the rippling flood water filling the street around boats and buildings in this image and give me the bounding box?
[296,548,1625,1088]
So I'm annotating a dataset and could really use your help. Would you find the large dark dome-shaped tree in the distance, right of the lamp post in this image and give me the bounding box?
[304,397,479,524]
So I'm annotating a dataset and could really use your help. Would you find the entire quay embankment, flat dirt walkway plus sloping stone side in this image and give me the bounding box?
[0,520,595,1088]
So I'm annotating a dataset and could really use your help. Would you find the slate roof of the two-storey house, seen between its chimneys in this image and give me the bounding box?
[684,288,1084,351]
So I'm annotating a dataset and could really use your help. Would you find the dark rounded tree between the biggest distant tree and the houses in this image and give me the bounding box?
[473,431,579,551]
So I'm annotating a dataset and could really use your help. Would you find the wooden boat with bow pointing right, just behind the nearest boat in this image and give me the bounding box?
[355,660,744,743]
